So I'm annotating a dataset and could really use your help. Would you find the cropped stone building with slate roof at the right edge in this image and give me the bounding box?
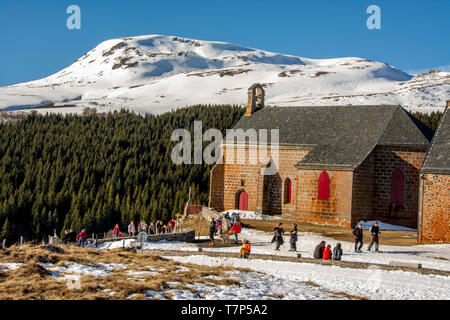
[418,100,450,243]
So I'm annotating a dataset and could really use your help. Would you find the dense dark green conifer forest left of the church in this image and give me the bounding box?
[0,105,244,240]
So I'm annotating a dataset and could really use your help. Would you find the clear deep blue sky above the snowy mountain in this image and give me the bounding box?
[0,0,450,86]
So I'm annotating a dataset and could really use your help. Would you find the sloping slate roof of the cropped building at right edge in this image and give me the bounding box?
[421,108,450,174]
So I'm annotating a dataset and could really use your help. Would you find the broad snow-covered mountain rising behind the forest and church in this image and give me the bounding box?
[0,35,450,114]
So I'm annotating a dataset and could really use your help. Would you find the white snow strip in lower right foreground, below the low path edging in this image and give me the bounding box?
[166,255,450,300]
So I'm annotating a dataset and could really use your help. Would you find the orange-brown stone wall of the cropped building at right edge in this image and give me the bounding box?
[419,174,450,243]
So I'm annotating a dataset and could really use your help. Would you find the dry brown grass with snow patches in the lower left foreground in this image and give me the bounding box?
[0,245,243,300]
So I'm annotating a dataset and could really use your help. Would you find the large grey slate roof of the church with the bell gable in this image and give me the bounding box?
[235,105,430,168]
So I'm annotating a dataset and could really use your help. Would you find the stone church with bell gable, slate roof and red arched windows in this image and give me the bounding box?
[209,84,432,228]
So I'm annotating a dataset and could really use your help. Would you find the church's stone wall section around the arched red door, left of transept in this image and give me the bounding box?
[209,147,309,216]
